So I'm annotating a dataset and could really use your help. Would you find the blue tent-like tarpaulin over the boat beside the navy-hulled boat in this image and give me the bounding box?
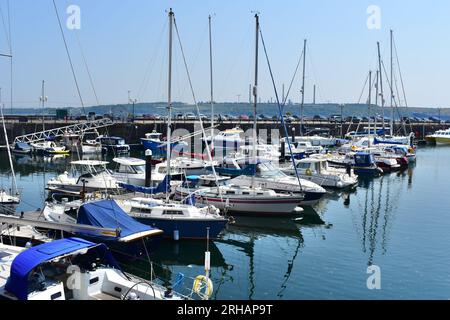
[77,200,154,240]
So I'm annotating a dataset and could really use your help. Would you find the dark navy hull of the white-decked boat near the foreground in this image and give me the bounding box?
[136,218,228,239]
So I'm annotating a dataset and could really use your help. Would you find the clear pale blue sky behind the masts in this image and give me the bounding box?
[0,0,450,107]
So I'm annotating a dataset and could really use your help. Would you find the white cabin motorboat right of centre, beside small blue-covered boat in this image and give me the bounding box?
[281,158,358,189]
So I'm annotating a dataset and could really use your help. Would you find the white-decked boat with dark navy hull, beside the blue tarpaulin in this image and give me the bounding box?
[118,197,228,240]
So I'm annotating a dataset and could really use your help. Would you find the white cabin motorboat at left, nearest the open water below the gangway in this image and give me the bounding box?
[47,160,120,193]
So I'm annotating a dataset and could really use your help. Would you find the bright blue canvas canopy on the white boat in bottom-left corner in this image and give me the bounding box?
[5,238,120,300]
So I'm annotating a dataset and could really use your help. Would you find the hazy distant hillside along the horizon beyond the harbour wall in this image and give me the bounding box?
[5,102,450,120]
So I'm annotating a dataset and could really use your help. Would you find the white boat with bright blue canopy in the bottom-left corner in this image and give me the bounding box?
[0,238,186,300]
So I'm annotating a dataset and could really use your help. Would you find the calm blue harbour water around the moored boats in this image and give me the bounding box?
[0,147,450,299]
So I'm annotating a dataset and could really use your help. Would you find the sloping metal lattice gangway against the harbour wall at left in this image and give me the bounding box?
[14,118,113,143]
